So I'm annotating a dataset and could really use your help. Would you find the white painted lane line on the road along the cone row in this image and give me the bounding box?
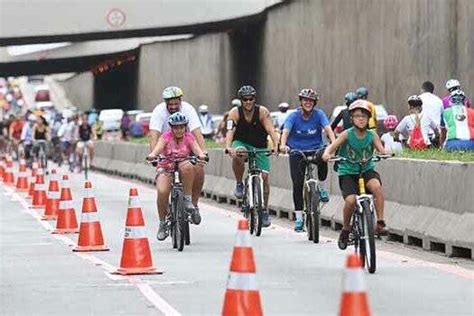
[4,187,181,316]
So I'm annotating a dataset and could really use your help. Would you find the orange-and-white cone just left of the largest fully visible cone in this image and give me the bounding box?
[73,181,109,251]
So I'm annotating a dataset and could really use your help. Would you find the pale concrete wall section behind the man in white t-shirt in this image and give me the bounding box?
[137,33,235,112]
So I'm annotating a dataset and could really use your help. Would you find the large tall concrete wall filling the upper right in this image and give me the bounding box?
[260,0,474,114]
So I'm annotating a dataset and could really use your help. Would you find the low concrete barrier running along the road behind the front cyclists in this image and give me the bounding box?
[93,141,474,259]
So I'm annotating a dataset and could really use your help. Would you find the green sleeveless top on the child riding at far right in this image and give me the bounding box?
[337,127,375,176]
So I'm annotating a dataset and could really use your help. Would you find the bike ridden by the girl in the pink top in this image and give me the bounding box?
[148,156,207,251]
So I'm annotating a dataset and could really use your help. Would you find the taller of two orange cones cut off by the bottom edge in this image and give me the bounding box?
[222,220,263,315]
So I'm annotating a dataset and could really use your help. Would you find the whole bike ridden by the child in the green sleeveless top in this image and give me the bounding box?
[330,155,392,273]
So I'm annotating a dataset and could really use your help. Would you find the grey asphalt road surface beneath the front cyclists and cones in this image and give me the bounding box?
[0,167,474,316]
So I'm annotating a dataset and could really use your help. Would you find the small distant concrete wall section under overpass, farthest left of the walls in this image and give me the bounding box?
[56,71,94,111]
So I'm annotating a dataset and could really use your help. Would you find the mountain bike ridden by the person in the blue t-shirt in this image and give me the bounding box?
[288,149,324,243]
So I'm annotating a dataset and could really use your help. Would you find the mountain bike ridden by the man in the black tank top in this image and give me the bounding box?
[226,148,273,236]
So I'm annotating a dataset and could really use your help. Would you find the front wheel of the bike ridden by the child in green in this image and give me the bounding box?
[360,201,376,273]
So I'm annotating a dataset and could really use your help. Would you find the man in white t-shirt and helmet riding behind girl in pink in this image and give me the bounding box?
[148,87,207,225]
